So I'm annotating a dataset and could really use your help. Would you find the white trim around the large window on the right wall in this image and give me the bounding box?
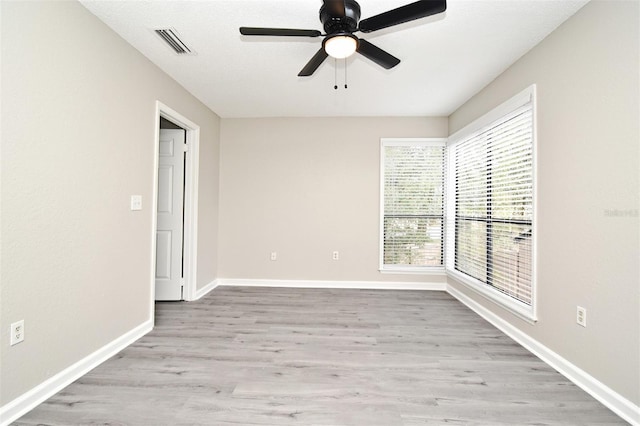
[444,84,538,323]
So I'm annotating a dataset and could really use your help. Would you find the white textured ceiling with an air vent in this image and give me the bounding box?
[80,0,588,118]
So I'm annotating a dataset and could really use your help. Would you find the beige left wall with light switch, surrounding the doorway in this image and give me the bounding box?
[0,1,219,406]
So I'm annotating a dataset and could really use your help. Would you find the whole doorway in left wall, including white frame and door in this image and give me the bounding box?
[151,102,200,304]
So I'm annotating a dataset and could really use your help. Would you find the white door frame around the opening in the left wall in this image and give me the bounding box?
[151,101,200,310]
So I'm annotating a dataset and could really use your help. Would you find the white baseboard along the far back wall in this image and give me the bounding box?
[217,278,447,291]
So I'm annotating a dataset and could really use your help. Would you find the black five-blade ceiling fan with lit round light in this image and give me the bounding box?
[240,0,447,77]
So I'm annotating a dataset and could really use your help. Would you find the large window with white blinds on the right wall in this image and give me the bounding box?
[447,87,535,319]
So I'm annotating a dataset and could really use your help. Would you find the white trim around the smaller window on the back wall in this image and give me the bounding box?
[378,138,448,276]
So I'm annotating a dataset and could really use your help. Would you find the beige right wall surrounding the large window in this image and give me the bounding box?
[449,1,640,404]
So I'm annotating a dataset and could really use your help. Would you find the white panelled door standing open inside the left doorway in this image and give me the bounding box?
[156,129,186,300]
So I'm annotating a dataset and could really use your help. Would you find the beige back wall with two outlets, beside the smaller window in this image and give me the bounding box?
[219,118,447,282]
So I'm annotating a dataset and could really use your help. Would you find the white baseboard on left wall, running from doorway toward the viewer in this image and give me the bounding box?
[0,320,153,426]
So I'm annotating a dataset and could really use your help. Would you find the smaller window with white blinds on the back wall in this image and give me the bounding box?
[380,139,445,271]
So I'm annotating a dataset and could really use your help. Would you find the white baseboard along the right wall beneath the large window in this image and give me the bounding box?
[447,286,640,426]
